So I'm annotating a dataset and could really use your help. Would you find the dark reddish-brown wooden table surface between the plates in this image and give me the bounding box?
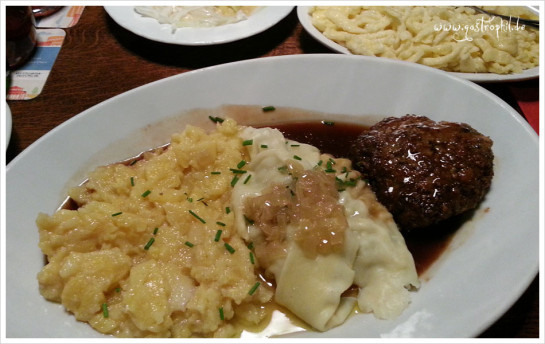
[6,7,540,338]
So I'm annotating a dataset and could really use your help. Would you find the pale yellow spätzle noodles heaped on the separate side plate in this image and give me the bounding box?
[309,6,539,74]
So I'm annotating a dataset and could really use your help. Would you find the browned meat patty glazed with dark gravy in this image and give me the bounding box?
[352,115,494,231]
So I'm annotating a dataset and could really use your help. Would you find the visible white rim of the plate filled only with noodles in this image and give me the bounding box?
[297,6,539,83]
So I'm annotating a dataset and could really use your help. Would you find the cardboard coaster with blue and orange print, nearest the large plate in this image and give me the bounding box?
[6,29,66,100]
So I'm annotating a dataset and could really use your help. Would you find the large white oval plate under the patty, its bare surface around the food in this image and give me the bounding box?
[4,54,541,338]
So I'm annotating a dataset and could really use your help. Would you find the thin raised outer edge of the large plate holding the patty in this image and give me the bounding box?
[6,55,539,336]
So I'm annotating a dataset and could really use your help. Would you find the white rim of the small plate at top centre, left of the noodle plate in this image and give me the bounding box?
[104,6,293,45]
